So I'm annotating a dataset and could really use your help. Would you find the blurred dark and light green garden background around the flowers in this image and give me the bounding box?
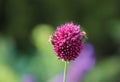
[0,0,120,82]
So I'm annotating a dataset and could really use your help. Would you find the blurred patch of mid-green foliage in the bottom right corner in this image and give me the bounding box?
[84,57,120,82]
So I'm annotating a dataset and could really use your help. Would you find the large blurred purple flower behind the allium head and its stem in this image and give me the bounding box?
[50,44,96,82]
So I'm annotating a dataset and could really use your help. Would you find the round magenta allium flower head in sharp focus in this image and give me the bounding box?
[51,22,85,61]
